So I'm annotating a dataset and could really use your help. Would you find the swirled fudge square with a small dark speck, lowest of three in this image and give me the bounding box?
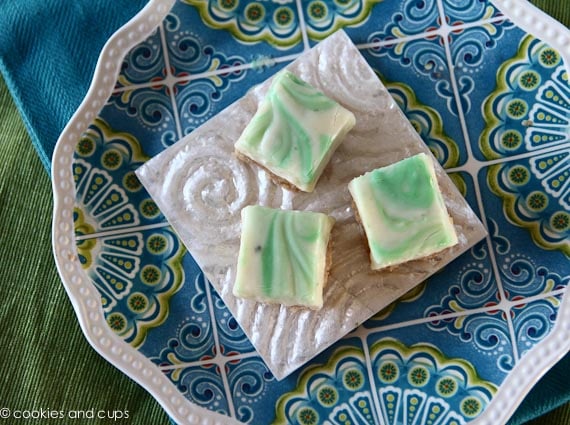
[233,205,334,309]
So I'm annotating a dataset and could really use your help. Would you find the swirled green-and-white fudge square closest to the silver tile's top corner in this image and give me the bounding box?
[235,71,355,192]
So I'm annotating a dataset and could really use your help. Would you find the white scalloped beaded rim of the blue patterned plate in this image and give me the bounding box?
[52,0,570,425]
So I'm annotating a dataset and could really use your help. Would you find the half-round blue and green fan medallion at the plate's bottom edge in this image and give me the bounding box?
[277,338,496,425]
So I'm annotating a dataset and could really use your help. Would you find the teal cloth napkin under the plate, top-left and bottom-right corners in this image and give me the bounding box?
[0,0,570,425]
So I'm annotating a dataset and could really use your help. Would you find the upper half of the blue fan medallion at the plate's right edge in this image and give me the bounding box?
[479,36,570,159]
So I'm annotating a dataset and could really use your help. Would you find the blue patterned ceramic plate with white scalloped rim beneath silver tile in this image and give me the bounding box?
[53,0,570,425]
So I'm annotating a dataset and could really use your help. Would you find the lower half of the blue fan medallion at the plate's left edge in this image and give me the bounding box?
[78,227,186,347]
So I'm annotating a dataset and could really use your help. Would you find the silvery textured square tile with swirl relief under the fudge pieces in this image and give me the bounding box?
[137,31,486,379]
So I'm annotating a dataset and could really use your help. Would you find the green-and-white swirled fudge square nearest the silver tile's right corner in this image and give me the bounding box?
[348,153,458,270]
